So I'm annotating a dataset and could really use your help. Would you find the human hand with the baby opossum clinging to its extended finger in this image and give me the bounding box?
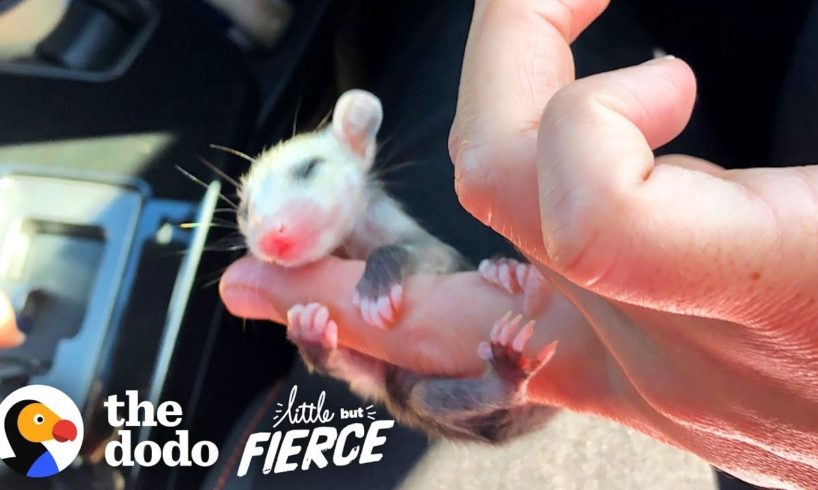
[222,0,818,487]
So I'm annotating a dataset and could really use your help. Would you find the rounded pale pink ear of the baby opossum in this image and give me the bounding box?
[332,89,383,167]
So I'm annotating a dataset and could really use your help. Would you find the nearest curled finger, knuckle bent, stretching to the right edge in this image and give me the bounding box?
[538,59,818,325]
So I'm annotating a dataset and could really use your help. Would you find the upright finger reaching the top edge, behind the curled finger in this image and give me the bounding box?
[449,0,609,255]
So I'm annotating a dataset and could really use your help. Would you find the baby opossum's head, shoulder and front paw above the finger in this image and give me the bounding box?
[238,90,469,327]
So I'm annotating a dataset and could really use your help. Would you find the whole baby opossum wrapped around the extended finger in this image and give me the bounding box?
[238,90,556,442]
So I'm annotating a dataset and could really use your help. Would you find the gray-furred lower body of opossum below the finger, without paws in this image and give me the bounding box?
[294,330,553,444]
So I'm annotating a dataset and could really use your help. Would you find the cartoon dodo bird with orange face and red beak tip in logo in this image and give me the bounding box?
[3,400,77,478]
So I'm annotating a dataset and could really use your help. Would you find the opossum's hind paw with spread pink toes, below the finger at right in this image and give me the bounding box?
[477,312,557,383]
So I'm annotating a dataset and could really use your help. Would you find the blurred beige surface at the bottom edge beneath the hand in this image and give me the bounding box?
[400,412,718,490]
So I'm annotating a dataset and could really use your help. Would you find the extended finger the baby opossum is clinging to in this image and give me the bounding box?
[220,256,521,374]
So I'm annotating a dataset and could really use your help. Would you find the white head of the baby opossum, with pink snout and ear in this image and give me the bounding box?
[238,90,383,267]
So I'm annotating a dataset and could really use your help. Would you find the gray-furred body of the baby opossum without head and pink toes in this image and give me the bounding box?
[280,174,552,443]
